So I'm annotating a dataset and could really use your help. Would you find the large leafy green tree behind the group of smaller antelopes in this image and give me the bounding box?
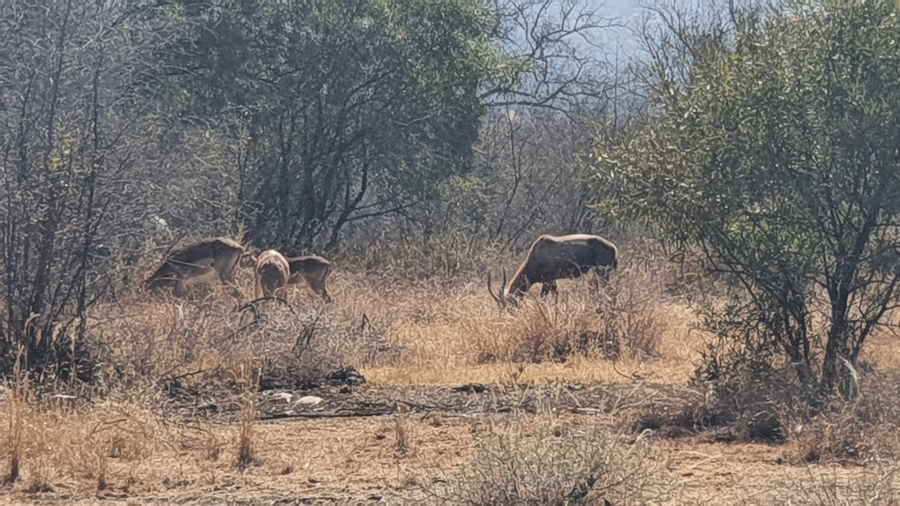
[167,0,524,251]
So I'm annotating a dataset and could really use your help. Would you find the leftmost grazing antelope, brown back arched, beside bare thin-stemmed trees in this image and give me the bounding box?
[144,237,244,298]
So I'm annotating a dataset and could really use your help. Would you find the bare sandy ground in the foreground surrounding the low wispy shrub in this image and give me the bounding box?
[0,384,894,504]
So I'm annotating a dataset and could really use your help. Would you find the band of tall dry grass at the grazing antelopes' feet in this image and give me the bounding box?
[79,241,700,388]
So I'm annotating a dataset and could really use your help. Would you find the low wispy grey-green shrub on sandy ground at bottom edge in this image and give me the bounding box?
[431,415,666,505]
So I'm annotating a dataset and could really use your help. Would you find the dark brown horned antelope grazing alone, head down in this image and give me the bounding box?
[487,234,619,306]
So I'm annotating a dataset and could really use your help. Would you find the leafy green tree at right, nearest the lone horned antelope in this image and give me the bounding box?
[595,0,900,401]
